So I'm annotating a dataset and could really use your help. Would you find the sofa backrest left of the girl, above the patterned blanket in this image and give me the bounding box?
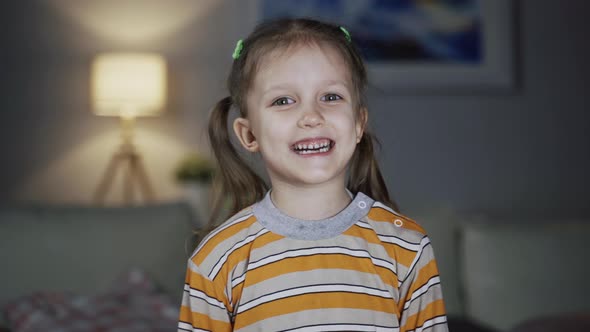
[0,203,199,312]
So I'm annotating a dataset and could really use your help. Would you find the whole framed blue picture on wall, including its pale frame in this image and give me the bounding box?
[258,0,514,94]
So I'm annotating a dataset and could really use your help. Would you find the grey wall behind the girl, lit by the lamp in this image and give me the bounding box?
[0,0,590,216]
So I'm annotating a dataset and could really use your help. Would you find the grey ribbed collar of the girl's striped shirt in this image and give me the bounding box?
[253,191,374,240]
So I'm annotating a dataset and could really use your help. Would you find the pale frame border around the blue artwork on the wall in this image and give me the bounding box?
[256,0,515,94]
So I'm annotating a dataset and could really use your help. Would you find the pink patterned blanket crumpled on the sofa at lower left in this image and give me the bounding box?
[3,269,178,332]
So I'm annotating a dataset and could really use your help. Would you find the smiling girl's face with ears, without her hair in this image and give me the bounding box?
[234,45,366,191]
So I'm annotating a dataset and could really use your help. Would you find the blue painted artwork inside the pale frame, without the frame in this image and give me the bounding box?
[262,0,482,63]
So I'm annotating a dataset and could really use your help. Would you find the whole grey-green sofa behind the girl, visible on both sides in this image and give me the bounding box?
[0,202,590,332]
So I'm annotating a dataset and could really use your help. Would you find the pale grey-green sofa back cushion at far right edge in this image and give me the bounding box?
[461,220,590,330]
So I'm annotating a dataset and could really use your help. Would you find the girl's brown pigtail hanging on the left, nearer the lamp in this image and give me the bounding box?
[209,96,267,228]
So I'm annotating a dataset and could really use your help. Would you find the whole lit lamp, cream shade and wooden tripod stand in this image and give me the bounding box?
[91,53,166,204]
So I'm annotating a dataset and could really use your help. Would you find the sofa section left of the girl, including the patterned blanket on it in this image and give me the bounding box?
[0,202,197,331]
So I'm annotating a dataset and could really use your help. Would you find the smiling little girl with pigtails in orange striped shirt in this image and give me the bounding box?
[178,19,447,331]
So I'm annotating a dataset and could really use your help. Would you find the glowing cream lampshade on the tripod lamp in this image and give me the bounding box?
[91,53,166,118]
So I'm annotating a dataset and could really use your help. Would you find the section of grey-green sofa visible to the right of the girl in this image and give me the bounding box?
[416,208,590,332]
